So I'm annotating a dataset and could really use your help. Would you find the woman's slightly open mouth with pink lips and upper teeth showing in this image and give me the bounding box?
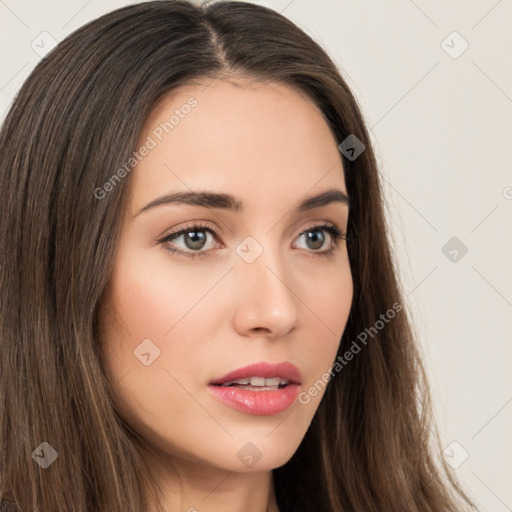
[208,362,302,416]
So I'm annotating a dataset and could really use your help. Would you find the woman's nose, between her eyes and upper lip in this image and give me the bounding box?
[233,250,300,339]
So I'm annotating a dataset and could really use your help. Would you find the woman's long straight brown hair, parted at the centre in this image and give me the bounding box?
[0,0,475,512]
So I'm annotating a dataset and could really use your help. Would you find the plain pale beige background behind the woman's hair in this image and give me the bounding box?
[0,0,512,512]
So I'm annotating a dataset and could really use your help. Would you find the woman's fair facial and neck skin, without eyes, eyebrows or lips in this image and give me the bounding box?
[102,79,353,512]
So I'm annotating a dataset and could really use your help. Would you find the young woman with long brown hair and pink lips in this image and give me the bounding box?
[0,0,474,512]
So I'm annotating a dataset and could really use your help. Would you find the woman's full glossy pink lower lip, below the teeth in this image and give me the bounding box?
[208,384,300,416]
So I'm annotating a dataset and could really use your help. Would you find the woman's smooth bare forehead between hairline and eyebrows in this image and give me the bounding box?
[128,80,346,211]
